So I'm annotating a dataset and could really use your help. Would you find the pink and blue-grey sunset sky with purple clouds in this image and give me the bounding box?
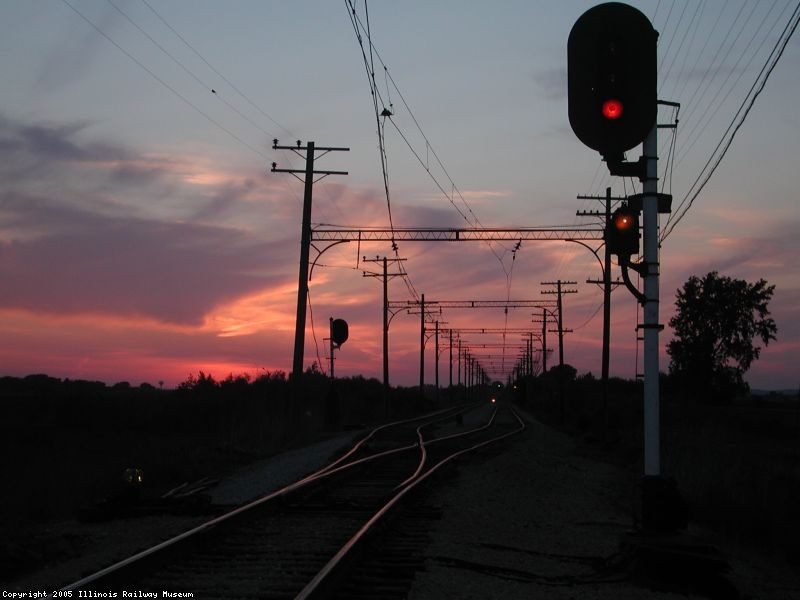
[0,0,800,389]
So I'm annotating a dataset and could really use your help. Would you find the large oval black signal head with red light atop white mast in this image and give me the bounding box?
[567,2,658,162]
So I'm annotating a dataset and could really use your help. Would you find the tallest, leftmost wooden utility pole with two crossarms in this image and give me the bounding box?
[272,139,350,379]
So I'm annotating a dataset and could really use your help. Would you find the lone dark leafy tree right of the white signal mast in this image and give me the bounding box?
[667,271,778,401]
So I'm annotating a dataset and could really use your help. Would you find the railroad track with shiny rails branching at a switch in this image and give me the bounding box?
[54,404,525,599]
